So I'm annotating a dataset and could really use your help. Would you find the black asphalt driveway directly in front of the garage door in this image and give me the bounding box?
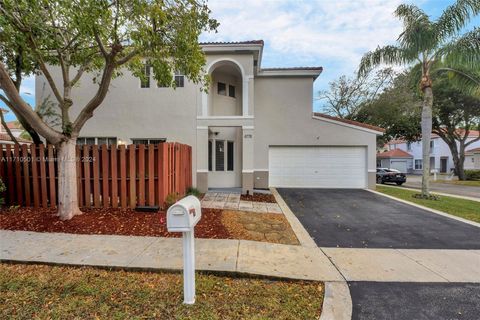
[278,189,480,249]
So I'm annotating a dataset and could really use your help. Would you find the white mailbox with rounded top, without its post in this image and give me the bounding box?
[167,196,202,232]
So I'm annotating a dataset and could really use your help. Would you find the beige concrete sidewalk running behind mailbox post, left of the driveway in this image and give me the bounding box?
[0,230,343,281]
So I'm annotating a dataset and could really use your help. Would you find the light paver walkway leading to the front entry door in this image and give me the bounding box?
[202,192,282,213]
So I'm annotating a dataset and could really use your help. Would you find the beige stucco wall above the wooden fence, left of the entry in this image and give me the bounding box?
[35,64,201,183]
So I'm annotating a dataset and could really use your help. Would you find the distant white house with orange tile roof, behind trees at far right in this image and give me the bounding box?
[377,130,480,174]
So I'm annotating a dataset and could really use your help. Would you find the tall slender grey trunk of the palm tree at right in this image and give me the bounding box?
[422,86,433,196]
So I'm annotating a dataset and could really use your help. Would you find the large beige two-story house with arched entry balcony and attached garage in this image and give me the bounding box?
[36,40,383,193]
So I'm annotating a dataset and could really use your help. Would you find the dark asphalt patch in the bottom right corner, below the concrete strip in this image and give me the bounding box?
[348,282,480,320]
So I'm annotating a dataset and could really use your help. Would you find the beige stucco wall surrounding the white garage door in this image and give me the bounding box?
[254,77,376,187]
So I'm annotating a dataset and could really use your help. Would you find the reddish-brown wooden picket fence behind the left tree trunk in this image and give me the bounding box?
[0,143,192,208]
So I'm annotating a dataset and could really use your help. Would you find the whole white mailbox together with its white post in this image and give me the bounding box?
[167,196,202,304]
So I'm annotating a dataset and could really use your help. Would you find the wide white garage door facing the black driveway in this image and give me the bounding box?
[268,147,367,188]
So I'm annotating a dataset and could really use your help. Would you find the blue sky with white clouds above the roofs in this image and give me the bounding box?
[0,0,480,120]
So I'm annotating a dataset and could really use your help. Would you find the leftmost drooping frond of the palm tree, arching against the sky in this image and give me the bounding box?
[358,46,413,76]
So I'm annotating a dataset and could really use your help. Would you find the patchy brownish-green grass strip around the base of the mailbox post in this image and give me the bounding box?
[0,264,323,319]
